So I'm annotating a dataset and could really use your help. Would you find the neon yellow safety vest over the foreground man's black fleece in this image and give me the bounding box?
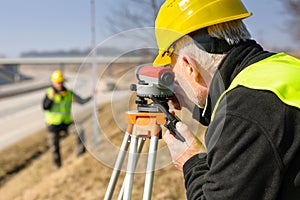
[211,53,300,121]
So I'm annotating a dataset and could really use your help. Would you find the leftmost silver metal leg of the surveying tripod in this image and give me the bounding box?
[104,132,130,200]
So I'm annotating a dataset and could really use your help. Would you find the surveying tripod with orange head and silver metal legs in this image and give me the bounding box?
[104,111,166,200]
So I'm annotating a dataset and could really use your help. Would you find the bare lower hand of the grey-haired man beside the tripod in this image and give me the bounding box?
[163,122,206,170]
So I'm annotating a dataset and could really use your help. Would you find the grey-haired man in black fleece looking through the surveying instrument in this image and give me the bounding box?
[153,0,300,200]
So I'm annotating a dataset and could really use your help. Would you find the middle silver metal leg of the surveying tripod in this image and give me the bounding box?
[124,135,138,200]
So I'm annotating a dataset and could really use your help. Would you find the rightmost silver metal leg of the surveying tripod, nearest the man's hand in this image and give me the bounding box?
[143,136,158,200]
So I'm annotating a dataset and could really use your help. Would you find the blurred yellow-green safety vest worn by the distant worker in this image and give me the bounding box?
[45,87,72,125]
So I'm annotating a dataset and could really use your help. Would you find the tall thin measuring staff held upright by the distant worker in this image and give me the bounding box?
[91,0,99,148]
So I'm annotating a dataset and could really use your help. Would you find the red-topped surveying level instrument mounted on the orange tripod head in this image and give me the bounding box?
[130,66,185,142]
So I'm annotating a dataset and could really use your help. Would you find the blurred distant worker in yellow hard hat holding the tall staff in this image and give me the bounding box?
[43,70,91,169]
